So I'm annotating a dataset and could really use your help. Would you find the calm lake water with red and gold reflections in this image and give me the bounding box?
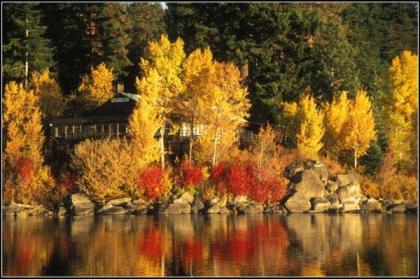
[3,214,418,276]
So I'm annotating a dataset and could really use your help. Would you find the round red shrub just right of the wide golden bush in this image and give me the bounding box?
[138,166,170,199]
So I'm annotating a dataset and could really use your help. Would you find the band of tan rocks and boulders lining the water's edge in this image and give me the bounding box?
[2,160,418,218]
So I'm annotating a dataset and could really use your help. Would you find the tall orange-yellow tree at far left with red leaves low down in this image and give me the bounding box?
[3,82,44,203]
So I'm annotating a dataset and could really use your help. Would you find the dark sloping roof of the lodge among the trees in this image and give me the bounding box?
[84,93,140,118]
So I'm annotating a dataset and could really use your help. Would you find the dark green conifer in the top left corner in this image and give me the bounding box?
[2,3,53,88]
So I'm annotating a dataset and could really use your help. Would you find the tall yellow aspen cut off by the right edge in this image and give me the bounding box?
[385,50,418,166]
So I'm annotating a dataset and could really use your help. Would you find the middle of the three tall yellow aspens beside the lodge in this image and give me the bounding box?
[179,48,215,161]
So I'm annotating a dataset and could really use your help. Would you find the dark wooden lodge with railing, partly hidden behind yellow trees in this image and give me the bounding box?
[47,92,261,159]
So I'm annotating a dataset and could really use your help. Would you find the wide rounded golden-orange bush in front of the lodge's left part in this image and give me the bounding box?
[72,139,138,201]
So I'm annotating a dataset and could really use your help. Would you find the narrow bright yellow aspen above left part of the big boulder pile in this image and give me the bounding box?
[296,95,325,157]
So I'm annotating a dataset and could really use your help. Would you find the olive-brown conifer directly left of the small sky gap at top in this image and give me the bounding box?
[125,3,166,92]
